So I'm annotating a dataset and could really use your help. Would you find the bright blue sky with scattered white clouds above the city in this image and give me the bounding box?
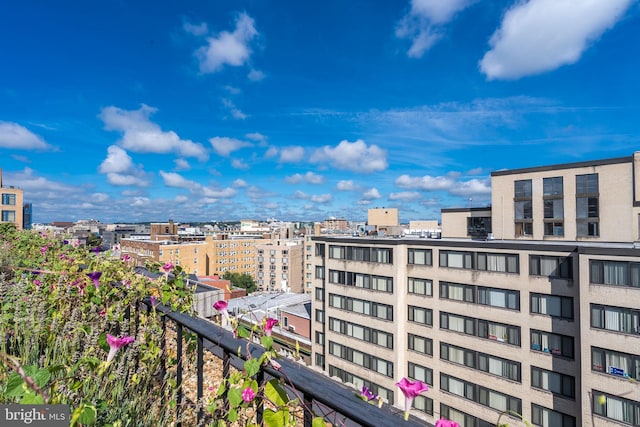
[0,0,640,222]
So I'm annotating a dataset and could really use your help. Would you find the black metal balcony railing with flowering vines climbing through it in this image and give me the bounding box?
[146,301,428,427]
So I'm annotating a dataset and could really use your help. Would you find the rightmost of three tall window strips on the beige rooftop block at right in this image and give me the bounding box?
[576,173,600,237]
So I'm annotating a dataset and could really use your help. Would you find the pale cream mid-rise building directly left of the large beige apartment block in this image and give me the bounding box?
[254,239,303,293]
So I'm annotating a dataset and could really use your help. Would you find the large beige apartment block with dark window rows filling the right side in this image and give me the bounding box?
[312,153,640,427]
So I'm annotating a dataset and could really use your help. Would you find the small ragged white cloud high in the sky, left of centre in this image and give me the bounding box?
[195,13,258,73]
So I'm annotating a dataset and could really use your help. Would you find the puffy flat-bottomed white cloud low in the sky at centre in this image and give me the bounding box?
[311,139,387,173]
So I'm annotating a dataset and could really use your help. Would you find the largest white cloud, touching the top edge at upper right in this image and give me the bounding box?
[480,0,634,79]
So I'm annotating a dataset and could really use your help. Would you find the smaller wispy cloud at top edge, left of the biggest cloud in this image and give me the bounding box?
[396,0,476,58]
